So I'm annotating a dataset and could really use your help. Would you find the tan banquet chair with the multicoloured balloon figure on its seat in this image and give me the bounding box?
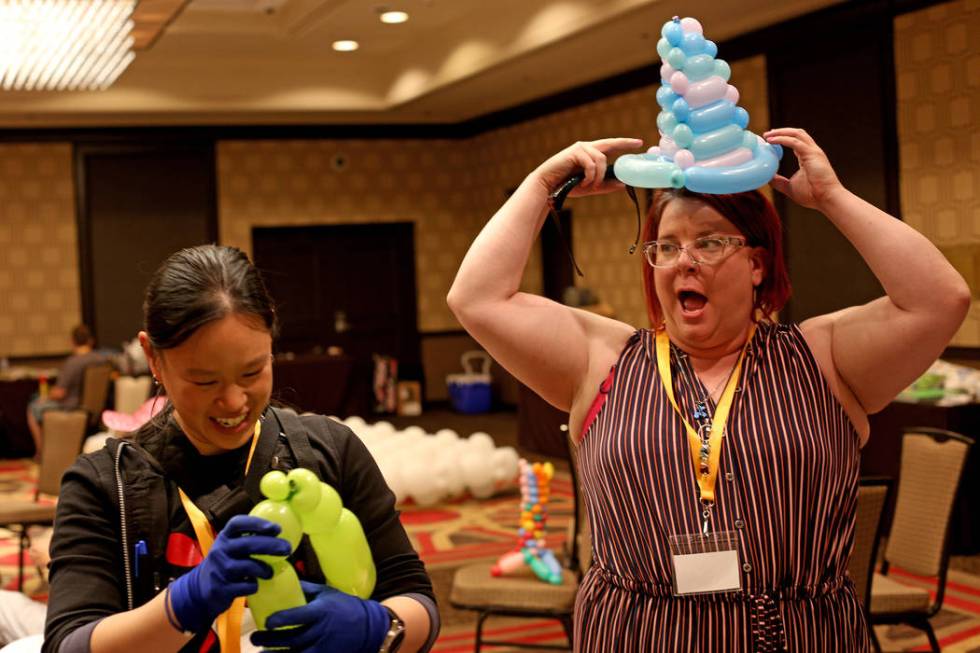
[449,428,591,653]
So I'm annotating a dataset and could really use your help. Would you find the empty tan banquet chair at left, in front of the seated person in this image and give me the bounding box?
[0,410,88,590]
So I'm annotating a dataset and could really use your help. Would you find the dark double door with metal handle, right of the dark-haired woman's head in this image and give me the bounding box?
[252,223,421,378]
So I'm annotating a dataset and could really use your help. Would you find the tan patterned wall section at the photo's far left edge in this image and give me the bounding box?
[0,144,81,356]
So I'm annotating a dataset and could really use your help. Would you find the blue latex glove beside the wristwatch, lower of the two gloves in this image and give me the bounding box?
[252,581,391,653]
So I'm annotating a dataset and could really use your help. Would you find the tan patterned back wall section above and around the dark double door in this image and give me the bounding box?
[218,140,490,331]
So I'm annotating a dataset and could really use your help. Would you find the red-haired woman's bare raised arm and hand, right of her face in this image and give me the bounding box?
[765,128,970,413]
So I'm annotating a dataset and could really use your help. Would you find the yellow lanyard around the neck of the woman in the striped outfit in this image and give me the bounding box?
[657,324,755,506]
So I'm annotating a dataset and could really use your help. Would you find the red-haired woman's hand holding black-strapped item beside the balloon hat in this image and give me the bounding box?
[531,138,643,197]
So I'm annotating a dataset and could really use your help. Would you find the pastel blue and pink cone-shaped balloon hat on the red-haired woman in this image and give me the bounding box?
[613,16,783,194]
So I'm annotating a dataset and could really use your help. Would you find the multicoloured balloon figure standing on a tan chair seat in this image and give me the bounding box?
[490,458,562,585]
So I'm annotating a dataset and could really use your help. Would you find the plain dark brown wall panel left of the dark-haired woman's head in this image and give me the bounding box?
[75,143,217,347]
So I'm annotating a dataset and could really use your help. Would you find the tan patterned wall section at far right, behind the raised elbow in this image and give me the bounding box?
[895,0,980,347]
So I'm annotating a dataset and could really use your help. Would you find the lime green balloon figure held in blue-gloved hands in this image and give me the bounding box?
[248,469,376,629]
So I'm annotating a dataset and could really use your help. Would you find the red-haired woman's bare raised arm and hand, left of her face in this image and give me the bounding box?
[447,138,642,410]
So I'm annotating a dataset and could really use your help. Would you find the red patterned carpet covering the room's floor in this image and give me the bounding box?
[0,460,980,653]
